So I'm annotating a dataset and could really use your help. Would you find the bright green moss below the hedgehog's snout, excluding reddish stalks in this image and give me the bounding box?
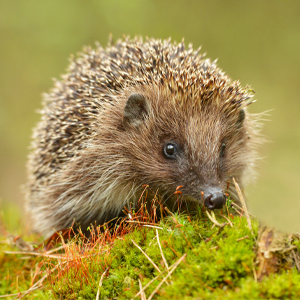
[47,215,298,299]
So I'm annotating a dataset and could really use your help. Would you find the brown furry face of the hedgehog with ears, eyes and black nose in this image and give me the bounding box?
[123,93,247,209]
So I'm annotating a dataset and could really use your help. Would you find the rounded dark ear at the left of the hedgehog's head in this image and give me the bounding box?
[123,94,149,127]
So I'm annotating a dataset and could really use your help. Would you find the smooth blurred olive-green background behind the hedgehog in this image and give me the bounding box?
[0,0,300,230]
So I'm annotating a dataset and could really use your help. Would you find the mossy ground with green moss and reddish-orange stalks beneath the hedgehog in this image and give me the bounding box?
[0,206,300,299]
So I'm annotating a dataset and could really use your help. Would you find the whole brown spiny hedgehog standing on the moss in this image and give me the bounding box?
[26,37,259,236]
